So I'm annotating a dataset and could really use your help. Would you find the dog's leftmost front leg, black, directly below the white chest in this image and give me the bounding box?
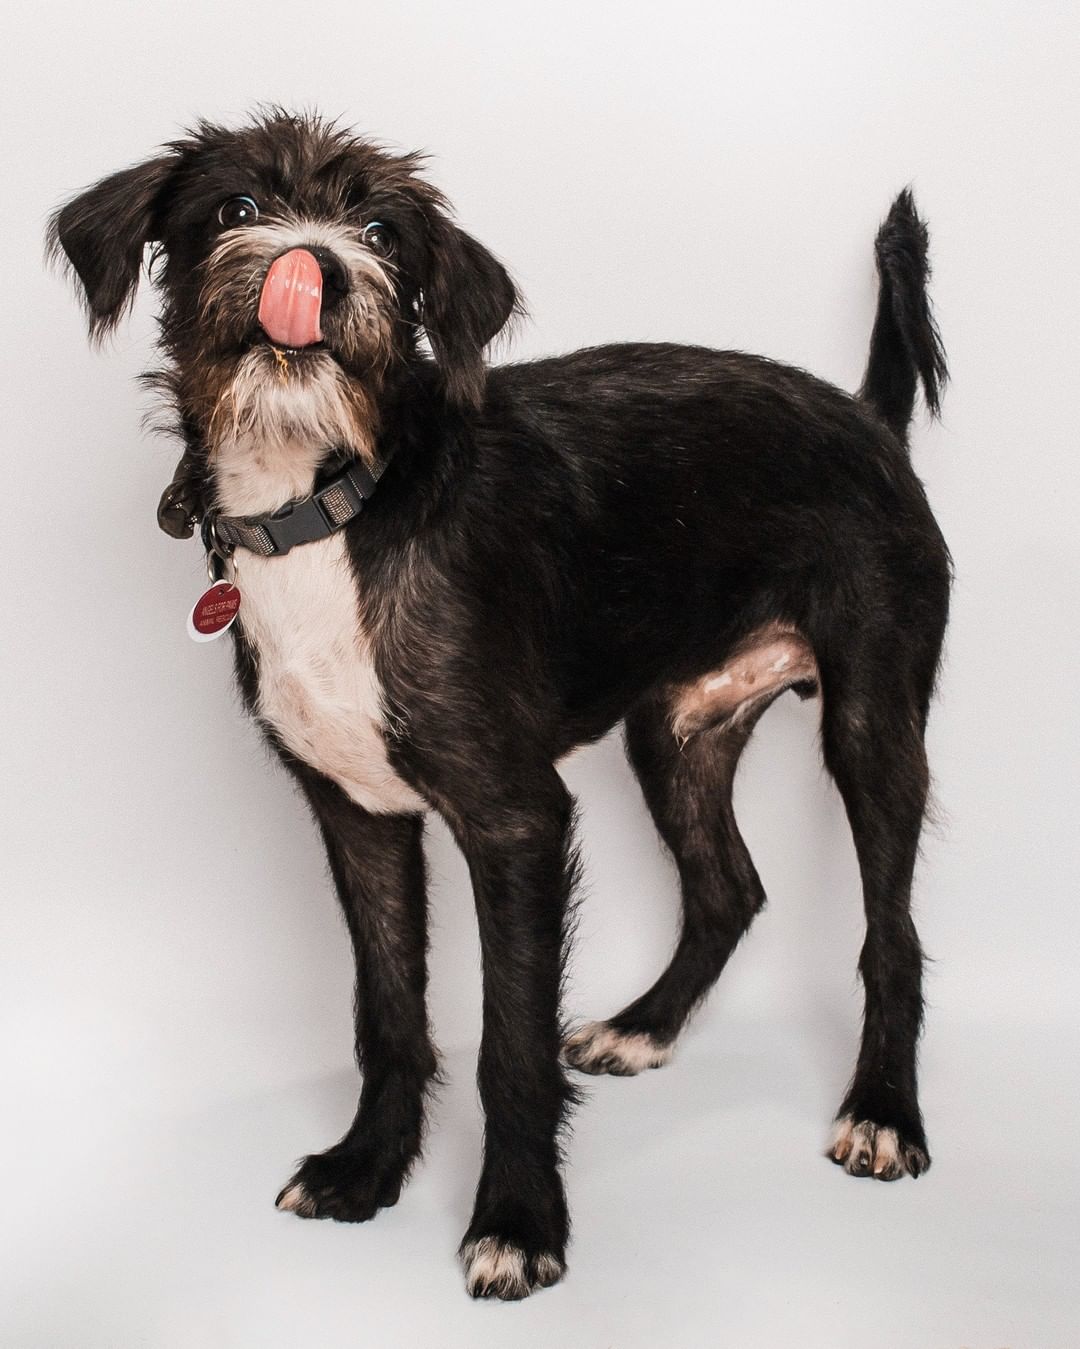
[278,765,436,1222]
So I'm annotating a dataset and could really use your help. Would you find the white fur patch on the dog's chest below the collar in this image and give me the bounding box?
[237,534,426,813]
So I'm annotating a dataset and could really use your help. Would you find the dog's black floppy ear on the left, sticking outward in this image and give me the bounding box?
[49,155,177,339]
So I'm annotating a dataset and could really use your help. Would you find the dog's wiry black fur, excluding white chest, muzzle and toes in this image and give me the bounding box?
[54,115,949,1296]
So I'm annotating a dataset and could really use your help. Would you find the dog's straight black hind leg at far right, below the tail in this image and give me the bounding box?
[822,650,932,1180]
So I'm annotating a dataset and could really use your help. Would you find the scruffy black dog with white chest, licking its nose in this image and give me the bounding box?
[50,109,951,1299]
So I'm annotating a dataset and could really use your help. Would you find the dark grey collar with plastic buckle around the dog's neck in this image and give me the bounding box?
[202,459,386,558]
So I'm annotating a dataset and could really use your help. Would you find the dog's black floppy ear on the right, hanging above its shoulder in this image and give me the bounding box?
[421,212,519,407]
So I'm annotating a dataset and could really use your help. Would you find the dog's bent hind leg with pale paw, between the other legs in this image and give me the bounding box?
[564,696,767,1074]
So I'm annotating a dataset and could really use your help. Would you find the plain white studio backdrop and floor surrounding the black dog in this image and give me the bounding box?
[0,0,1080,1349]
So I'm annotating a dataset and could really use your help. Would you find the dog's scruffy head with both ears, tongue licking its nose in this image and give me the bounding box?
[51,113,516,451]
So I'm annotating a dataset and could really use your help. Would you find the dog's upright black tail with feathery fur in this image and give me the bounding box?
[859,188,949,441]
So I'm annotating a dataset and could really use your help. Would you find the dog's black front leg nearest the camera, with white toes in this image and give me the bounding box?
[452,765,574,1299]
